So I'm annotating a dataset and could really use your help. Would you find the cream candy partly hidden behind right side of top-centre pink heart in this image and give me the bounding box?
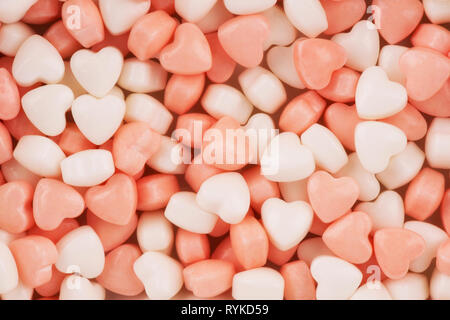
[262,5,297,50]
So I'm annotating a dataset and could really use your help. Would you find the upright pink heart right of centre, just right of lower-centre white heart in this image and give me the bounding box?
[307,171,359,223]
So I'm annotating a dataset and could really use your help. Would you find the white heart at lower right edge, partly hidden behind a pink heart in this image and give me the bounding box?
[405,221,448,273]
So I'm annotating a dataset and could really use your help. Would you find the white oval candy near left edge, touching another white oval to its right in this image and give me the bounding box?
[13,136,66,178]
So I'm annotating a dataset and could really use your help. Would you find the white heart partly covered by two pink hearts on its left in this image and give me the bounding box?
[355,191,405,234]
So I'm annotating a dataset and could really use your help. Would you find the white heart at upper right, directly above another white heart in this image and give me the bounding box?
[355,67,408,120]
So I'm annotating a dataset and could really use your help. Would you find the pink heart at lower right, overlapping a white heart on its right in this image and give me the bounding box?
[373,228,425,279]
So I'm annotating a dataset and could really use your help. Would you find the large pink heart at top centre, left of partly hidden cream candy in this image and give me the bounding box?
[218,14,270,68]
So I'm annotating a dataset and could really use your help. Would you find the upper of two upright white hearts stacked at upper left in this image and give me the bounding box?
[70,47,123,98]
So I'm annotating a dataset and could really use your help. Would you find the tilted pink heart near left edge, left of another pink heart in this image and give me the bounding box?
[33,179,84,230]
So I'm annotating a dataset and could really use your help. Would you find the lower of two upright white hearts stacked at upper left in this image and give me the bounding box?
[72,94,126,145]
